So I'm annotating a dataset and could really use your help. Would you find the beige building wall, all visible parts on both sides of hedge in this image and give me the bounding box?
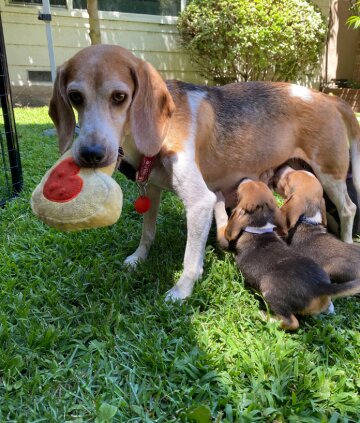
[0,0,360,104]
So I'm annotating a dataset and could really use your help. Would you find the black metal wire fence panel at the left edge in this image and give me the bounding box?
[0,15,22,206]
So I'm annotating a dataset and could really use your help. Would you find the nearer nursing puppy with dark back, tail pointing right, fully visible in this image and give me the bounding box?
[214,179,360,330]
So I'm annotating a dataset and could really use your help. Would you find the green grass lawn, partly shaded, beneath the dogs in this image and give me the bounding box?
[0,108,360,423]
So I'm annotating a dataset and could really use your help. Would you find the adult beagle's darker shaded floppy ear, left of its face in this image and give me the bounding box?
[49,64,75,154]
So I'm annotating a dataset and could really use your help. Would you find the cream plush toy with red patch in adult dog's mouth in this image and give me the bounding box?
[31,151,122,231]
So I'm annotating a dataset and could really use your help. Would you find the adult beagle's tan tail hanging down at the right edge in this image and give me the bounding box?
[336,99,360,197]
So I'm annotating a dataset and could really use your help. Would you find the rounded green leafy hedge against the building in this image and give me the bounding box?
[178,0,327,84]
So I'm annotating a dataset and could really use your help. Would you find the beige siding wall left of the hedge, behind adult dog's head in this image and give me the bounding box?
[0,0,204,104]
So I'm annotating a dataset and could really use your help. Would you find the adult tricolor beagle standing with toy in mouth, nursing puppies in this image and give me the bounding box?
[49,45,360,299]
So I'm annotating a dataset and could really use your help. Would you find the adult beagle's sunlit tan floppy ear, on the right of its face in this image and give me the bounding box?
[130,61,175,156]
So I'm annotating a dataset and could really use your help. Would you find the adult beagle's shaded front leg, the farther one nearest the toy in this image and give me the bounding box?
[124,185,161,267]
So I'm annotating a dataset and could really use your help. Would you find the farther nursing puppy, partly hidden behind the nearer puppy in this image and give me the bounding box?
[274,166,360,282]
